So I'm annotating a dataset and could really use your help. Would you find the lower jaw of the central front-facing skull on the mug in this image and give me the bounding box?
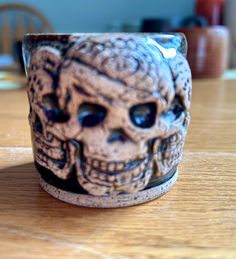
[76,159,153,196]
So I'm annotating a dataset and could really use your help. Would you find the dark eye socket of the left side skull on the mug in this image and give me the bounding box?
[42,94,69,123]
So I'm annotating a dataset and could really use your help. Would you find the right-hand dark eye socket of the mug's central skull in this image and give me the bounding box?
[129,103,157,129]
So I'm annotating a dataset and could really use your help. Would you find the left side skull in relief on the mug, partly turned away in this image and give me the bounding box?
[28,48,75,179]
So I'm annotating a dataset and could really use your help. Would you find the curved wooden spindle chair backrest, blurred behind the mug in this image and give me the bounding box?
[0,3,53,55]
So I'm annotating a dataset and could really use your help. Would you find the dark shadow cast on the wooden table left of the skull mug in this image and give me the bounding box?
[0,163,145,226]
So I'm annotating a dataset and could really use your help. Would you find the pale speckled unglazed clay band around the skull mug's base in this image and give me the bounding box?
[40,170,178,208]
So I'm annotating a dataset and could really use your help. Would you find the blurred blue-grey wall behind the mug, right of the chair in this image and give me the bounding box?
[0,0,194,32]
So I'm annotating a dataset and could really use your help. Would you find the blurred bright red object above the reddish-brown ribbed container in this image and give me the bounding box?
[196,0,225,25]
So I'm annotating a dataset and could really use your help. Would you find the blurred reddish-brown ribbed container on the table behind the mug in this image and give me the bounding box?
[179,26,229,78]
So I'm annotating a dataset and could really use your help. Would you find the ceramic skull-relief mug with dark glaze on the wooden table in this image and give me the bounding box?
[23,33,191,207]
